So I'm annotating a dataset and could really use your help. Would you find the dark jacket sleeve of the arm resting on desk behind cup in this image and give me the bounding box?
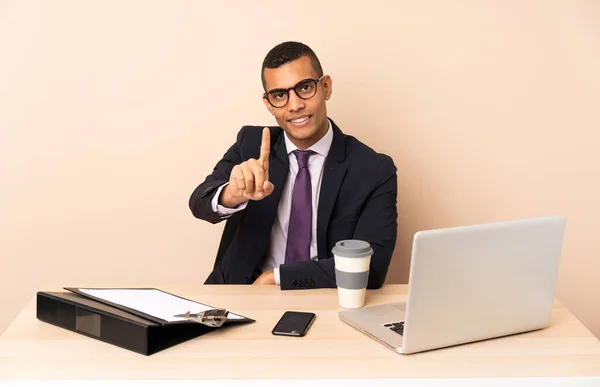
[279,156,398,290]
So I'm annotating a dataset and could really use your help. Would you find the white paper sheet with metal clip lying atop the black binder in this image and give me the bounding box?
[64,287,255,328]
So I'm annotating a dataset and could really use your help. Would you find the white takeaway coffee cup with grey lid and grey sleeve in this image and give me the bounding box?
[331,239,373,308]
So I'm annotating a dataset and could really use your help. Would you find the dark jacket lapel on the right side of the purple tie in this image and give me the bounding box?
[317,120,347,259]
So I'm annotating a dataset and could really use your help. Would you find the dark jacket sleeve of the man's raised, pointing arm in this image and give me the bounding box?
[189,127,245,223]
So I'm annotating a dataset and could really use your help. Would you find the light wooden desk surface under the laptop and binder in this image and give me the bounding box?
[0,285,600,380]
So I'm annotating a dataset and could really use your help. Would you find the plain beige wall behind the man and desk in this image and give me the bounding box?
[0,0,600,335]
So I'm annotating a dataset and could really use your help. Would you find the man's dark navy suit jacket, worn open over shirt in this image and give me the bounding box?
[189,121,398,290]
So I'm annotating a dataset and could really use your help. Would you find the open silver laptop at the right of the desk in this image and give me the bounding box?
[339,215,566,354]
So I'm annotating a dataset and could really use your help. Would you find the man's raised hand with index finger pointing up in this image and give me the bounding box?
[219,128,274,208]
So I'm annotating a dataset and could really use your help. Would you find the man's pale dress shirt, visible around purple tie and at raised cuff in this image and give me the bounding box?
[211,120,333,285]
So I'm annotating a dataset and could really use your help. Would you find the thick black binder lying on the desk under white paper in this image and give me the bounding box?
[36,288,254,356]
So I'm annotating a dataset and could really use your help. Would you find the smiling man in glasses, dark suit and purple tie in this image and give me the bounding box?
[189,42,398,290]
